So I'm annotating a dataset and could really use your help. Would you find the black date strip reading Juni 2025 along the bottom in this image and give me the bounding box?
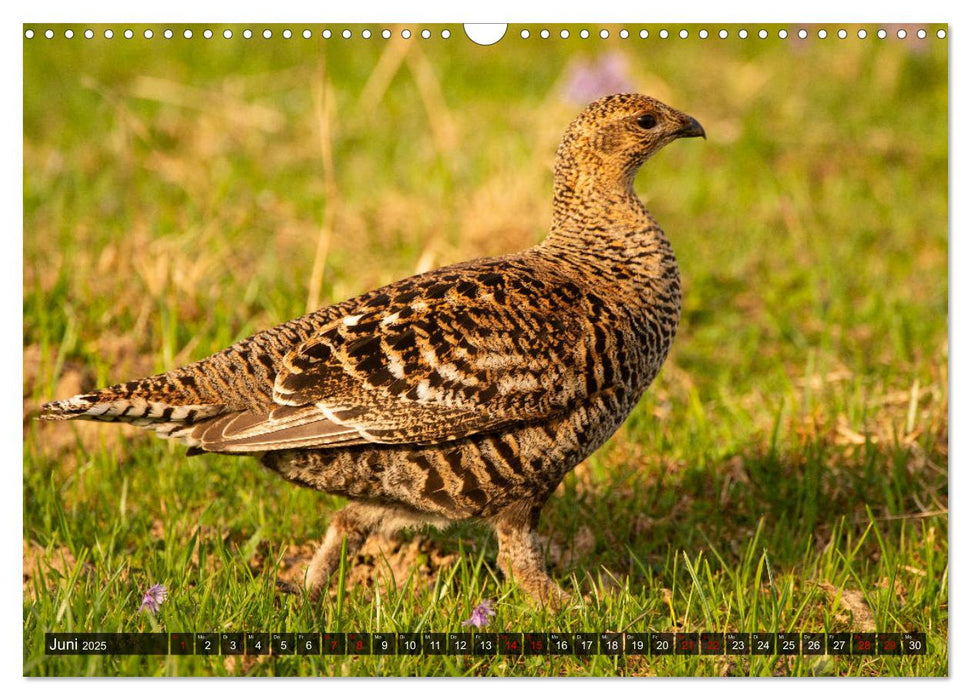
[44,632,927,657]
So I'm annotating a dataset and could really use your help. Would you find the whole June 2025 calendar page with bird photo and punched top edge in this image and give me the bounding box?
[22,17,950,677]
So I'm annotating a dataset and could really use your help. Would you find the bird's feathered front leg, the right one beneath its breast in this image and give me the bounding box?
[493,506,570,607]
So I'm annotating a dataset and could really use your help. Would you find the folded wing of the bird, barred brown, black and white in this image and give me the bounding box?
[190,269,597,452]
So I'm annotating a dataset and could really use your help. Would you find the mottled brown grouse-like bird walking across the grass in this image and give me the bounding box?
[40,93,706,606]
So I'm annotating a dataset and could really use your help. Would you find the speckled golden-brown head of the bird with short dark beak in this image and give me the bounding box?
[556,94,705,187]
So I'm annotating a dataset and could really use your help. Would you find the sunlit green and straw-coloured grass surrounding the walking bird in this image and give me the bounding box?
[23,26,949,676]
